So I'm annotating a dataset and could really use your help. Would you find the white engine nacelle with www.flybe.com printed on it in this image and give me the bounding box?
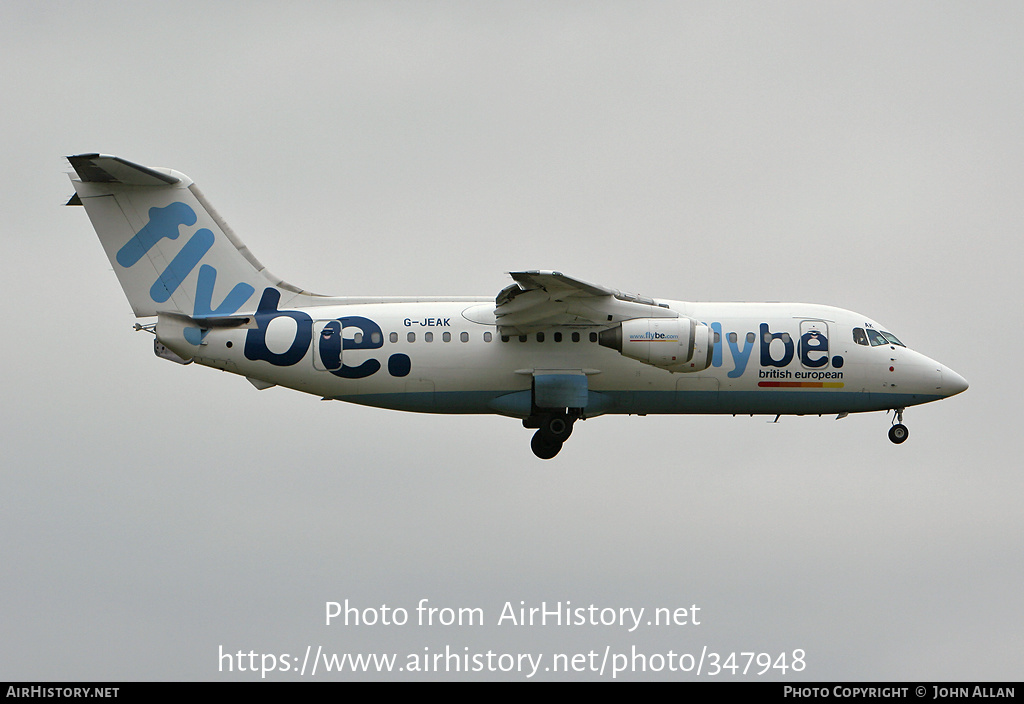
[598,317,715,371]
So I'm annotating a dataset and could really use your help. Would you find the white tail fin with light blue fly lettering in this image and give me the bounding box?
[68,153,316,318]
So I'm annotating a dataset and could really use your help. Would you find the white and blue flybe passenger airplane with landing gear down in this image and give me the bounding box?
[67,153,968,459]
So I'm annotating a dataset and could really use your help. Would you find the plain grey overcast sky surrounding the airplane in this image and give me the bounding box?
[0,0,1024,680]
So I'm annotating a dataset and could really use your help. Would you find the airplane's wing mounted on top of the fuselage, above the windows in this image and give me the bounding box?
[495,271,679,335]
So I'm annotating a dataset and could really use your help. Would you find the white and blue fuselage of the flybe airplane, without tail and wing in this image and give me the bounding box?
[172,298,965,417]
